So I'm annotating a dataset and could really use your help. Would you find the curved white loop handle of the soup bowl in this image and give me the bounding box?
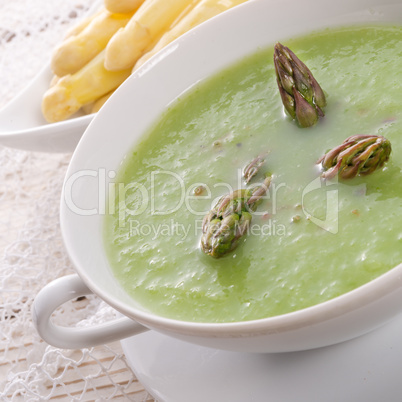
[32,275,148,349]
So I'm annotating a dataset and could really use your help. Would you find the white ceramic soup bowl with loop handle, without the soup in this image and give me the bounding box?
[33,0,402,352]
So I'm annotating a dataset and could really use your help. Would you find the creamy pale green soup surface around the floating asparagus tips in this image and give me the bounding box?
[104,26,402,322]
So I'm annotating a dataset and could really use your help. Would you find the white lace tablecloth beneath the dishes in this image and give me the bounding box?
[0,0,152,401]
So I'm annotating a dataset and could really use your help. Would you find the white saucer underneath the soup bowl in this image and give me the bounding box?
[121,315,402,402]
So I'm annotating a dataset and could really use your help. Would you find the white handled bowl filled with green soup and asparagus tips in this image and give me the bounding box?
[33,0,402,352]
